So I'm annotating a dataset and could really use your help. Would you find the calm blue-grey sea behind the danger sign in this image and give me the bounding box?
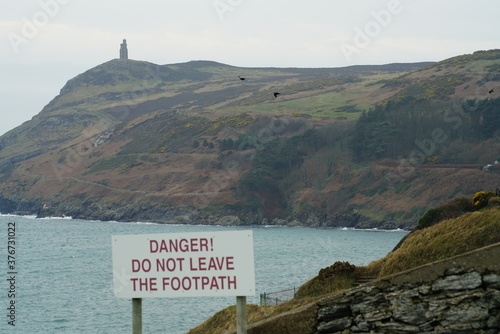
[0,215,407,334]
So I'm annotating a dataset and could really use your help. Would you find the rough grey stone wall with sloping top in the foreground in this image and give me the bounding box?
[228,244,500,334]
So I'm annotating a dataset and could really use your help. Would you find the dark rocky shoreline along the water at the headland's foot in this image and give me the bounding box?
[0,196,415,230]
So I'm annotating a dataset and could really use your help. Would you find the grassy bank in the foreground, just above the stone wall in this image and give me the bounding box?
[189,197,500,334]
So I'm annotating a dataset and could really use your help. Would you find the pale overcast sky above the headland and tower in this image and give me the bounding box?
[0,0,500,135]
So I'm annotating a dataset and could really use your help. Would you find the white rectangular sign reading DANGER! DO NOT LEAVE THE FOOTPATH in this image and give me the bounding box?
[112,231,255,298]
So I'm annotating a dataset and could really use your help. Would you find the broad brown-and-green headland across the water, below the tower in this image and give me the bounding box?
[0,51,500,228]
